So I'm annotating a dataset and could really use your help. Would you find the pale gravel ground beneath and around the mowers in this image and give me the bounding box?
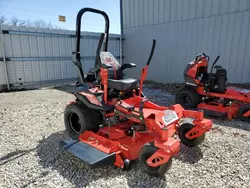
[0,84,250,188]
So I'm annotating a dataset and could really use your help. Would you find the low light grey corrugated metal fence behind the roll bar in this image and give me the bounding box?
[0,25,120,87]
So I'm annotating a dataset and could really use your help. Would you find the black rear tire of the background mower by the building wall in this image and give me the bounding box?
[175,88,201,108]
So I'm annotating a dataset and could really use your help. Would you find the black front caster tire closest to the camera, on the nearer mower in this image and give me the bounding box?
[139,144,172,177]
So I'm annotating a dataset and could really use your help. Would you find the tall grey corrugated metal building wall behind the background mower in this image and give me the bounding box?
[122,0,250,83]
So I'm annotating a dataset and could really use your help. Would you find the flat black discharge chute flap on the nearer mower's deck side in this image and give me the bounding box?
[61,139,116,168]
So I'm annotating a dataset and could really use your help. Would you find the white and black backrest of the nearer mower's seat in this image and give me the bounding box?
[100,52,123,79]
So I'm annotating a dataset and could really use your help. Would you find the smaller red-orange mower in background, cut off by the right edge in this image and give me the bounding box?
[176,53,250,122]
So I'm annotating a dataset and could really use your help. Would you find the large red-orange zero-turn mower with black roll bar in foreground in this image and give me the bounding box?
[61,8,212,176]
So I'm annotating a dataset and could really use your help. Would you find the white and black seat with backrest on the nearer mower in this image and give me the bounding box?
[100,52,139,91]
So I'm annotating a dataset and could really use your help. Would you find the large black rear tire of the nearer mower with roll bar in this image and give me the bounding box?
[64,102,101,140]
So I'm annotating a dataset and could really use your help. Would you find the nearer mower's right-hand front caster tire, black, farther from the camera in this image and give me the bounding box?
[178,123,205,147]
